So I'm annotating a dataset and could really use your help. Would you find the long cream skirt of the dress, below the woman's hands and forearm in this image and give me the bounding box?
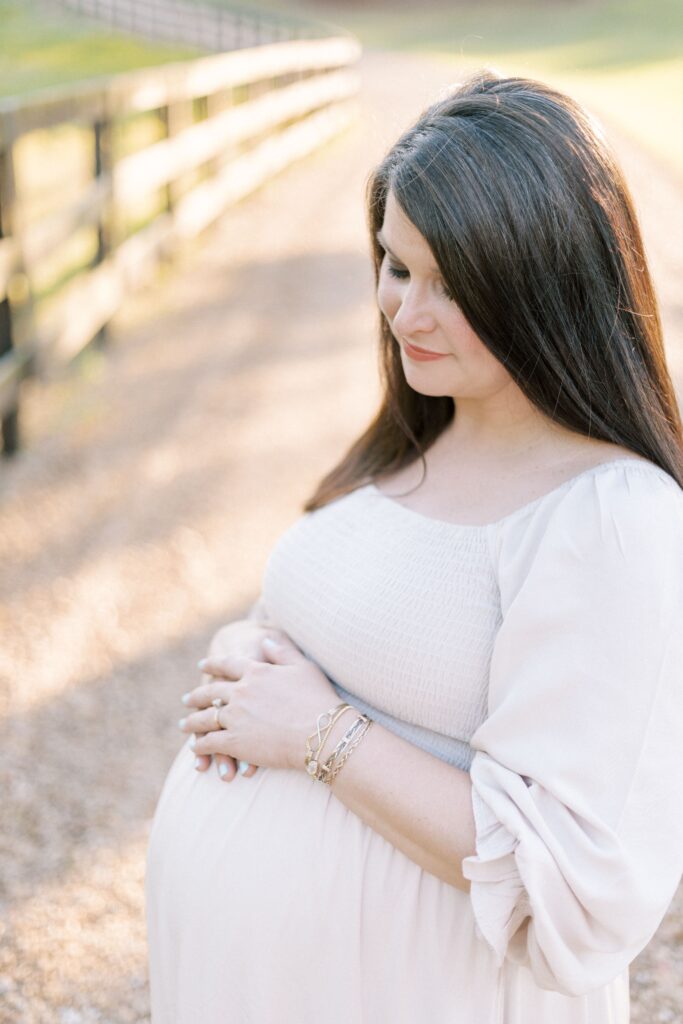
[145,743,628,1024]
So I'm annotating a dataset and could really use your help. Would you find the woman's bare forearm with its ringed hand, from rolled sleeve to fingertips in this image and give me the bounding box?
[183,639,475,892]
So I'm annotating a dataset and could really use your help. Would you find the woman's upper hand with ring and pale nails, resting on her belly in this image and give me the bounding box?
[182,638,339,769]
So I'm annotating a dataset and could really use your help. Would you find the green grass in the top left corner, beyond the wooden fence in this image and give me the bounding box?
[0,0,198,96]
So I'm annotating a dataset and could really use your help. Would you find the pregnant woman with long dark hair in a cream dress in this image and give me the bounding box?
[146,72,683,1024]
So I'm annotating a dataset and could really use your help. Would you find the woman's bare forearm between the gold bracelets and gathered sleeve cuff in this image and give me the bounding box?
[301,712,475,892]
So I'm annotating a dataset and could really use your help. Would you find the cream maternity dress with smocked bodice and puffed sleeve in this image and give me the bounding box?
[146,458,683,1024]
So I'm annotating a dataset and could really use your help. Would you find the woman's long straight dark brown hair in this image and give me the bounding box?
[304,71,683,511]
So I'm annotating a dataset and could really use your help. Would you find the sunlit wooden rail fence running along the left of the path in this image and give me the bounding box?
[0,36,360,455]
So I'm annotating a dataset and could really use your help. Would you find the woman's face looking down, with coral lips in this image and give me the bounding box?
[377,191,512,399]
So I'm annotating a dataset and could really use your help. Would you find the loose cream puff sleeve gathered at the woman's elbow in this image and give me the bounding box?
[462,461,683,995]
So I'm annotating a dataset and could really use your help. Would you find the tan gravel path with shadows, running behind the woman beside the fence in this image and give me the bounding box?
[0,53,683,1024]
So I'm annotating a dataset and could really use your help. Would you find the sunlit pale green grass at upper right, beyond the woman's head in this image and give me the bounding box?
[205,0,683,174]
